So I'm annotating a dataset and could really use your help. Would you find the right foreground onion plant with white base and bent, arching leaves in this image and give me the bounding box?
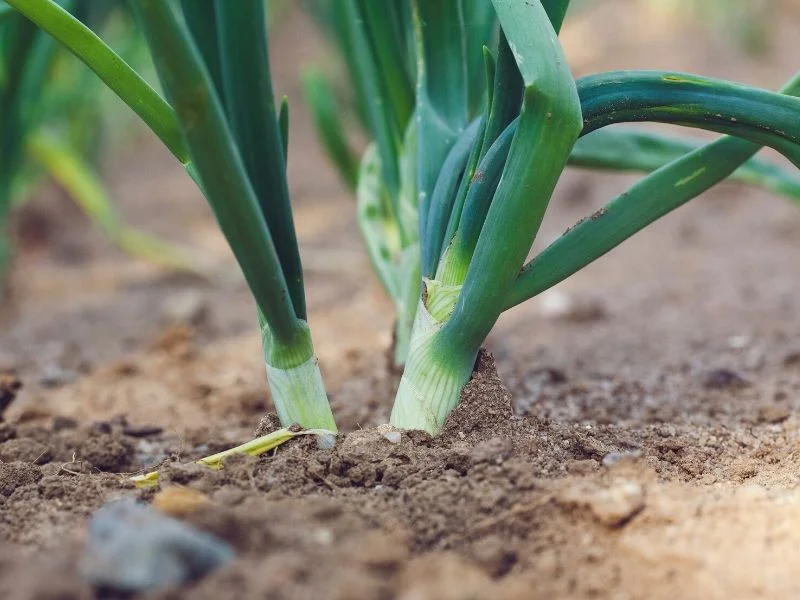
[391,0,800,434]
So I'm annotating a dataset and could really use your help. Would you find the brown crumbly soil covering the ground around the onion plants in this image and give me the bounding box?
[0,0,800,600]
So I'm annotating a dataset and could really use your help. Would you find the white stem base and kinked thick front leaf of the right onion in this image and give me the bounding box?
[391,0,582,433]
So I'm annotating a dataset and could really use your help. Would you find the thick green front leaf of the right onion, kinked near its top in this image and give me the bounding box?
[439,0,581,353]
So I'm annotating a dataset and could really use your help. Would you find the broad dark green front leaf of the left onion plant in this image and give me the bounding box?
[134,0,303,345]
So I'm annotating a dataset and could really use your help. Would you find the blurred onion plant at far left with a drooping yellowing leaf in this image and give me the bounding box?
[0,0,195,298]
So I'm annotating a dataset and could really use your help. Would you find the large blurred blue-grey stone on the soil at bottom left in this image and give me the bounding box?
[80,498,235,593]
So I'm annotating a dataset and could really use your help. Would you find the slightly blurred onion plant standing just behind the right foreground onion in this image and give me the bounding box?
[303,0,800,368]
